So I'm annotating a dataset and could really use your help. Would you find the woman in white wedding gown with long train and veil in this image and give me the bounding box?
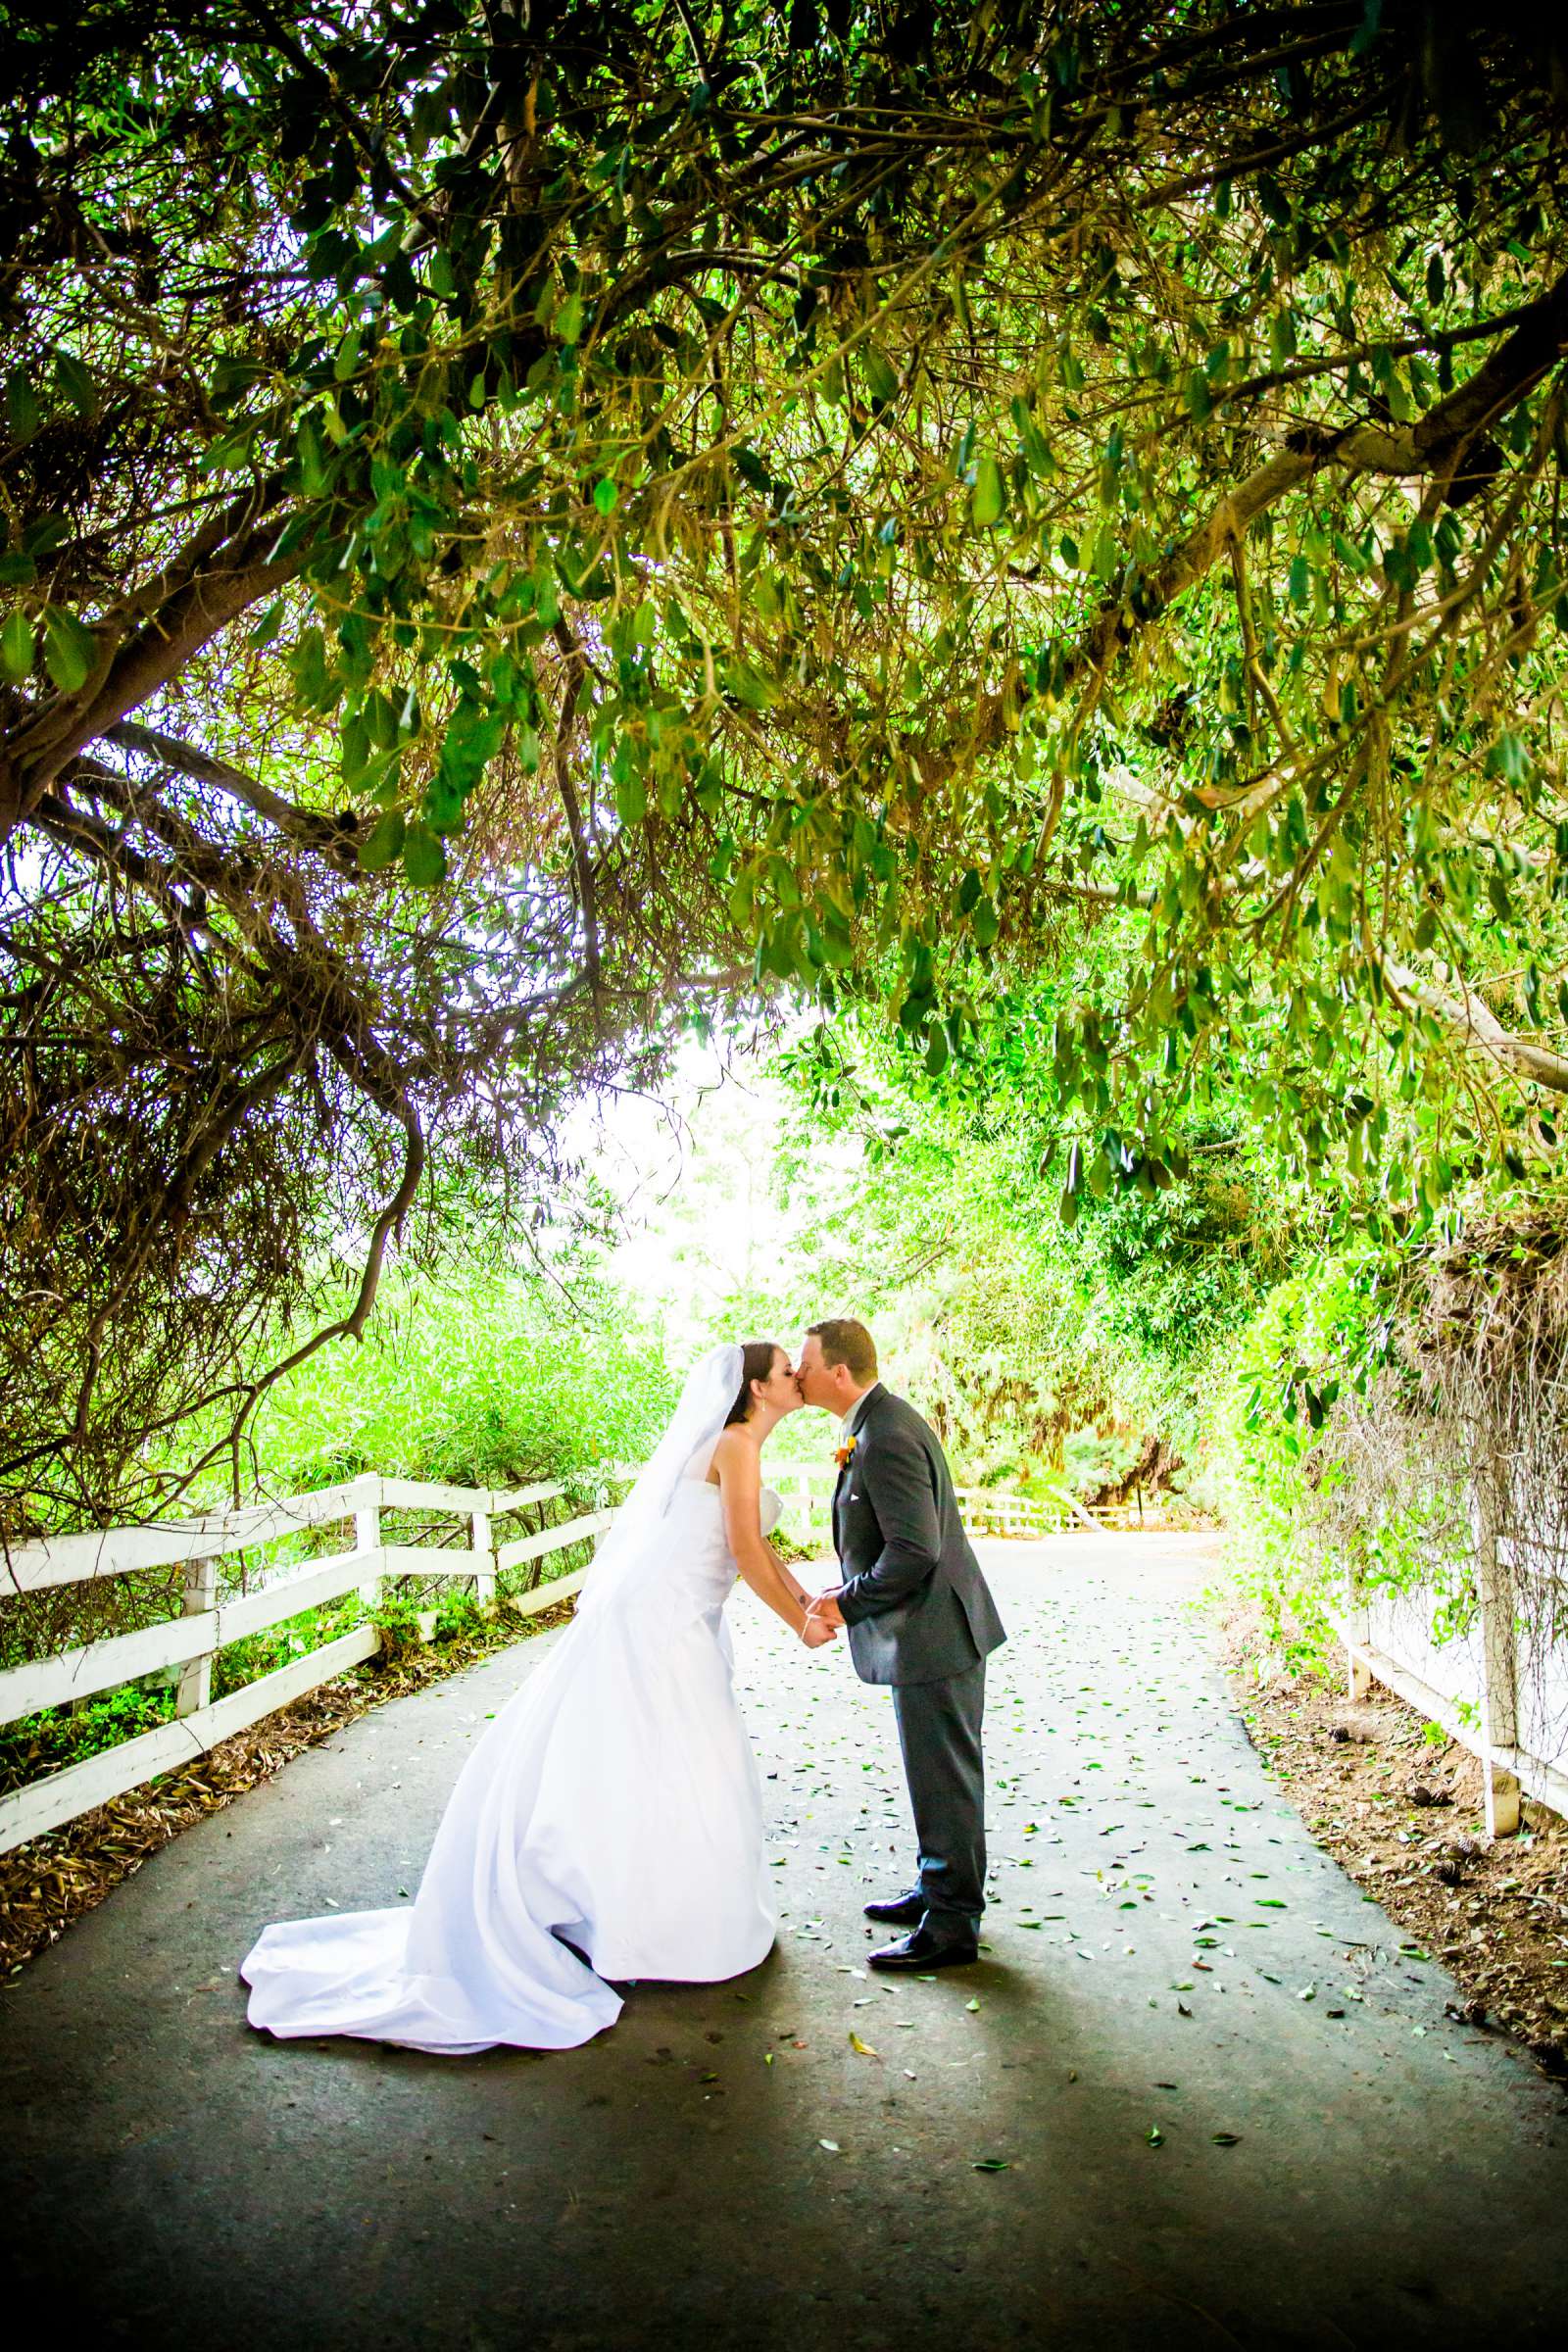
[240,1341,832,2056]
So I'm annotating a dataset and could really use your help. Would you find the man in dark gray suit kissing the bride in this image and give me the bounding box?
[795,1322,1006,1974]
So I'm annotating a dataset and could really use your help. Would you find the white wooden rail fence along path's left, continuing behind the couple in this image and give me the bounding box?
[0,1465,1093,1853]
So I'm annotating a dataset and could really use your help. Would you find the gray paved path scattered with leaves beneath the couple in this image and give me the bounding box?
[0,1536,1568,2352]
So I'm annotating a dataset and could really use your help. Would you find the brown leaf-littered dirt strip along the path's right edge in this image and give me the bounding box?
[1225,1613,1568,2077]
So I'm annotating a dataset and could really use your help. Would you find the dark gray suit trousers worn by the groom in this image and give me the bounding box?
[894,1658,985,1942]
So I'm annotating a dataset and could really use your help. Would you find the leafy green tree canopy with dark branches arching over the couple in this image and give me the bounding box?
[0,0,1568,1522]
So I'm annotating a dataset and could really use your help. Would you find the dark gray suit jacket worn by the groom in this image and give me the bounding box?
[832,1386,1006,1682]
